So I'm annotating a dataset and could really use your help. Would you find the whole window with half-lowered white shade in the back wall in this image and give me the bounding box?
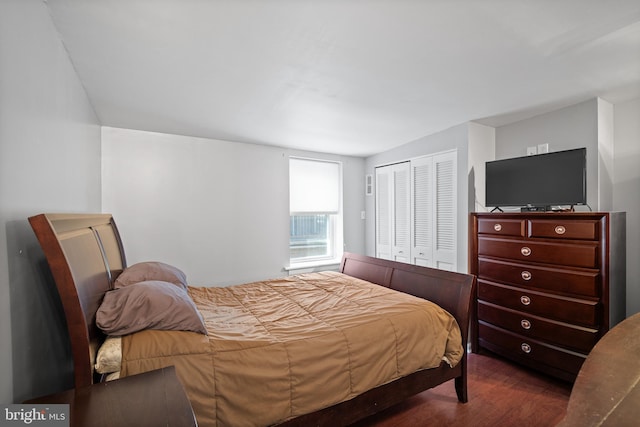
[289,157,342,264]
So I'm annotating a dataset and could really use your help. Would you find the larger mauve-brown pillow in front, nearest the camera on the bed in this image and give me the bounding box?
[96,280,207,336]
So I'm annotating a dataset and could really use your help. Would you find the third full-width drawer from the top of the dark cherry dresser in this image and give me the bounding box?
[478,279,600,328]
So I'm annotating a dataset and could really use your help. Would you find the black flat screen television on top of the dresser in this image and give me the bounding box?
[485,148,587,210]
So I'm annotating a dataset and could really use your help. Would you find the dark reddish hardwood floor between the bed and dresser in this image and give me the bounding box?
[352,352,572,427]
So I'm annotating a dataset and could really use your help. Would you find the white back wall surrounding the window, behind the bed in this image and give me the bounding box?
[102,127,364,286]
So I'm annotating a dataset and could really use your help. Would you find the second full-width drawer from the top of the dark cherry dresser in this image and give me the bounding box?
[478,258,600,297]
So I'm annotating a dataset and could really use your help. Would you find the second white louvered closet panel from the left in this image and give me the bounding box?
[391,162,411,263]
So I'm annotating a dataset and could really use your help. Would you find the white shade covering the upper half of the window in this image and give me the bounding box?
[289,158,340,214]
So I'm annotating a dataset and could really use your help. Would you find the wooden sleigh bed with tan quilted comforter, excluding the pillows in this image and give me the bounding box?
[29,214,475,426]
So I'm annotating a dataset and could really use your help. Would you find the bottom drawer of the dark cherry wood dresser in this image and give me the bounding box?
[478,322,587,376]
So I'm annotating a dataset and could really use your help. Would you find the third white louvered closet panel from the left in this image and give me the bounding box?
[411,157,435,267]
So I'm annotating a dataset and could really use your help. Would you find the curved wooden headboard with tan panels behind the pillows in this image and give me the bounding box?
[29,214,127,387]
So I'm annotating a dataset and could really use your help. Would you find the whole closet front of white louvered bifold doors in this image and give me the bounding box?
[375,151,457,271]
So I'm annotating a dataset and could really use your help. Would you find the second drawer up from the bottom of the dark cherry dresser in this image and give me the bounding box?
[478,301,598,354]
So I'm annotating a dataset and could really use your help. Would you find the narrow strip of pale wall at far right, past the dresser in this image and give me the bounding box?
[613,98,640,316]
